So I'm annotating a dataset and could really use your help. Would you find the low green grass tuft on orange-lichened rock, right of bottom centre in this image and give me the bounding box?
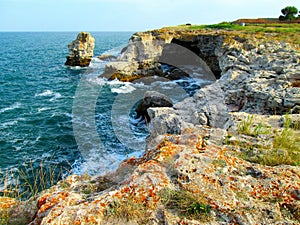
[159,188,211,222]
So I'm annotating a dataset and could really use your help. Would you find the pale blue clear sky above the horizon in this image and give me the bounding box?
[0,0,300,31]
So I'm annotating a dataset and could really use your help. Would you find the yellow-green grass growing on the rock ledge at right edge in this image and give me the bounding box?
[232,116,300,166]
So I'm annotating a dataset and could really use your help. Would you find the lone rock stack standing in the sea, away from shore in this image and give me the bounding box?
[65,32,95,67]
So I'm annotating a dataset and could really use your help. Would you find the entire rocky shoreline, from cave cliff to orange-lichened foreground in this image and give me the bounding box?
[0,25,300,225]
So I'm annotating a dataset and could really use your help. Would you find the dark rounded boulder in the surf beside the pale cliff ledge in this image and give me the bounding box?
[135,91,173,121]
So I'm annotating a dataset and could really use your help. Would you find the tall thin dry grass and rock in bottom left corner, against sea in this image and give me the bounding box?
[0,159,71,225]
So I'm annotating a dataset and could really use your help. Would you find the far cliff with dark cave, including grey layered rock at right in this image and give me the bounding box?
[104,29,300,114]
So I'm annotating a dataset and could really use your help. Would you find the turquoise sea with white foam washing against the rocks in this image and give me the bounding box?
[0,32,206,191]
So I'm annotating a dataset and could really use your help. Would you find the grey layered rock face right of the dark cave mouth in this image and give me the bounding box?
[219,42,300,114]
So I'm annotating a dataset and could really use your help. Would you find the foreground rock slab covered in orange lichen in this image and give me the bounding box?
[4,125,300,225]
